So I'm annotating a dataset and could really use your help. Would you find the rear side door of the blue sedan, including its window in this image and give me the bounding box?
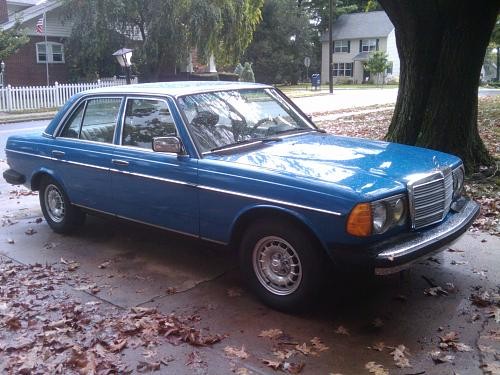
[50,96,123,212]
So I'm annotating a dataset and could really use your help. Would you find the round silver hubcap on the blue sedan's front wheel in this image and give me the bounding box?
[253,236,302,296]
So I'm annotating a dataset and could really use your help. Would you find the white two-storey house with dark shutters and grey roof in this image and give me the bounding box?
[321,11,399,83]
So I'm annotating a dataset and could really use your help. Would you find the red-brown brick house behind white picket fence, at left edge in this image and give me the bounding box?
[0,0,71,86]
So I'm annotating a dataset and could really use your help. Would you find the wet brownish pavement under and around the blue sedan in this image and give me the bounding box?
[0,156,500,374]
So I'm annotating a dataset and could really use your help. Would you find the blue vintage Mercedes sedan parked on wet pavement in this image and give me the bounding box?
[3,82,479,310]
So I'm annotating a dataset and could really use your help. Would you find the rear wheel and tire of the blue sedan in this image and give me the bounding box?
[39,176,85,234]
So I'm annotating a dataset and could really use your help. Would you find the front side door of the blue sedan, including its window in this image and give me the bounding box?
[111,97,199,236]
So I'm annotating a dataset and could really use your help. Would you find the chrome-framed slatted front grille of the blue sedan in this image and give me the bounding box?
[408,168,453,229]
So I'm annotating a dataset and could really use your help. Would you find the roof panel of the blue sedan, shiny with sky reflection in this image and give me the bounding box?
[82,81,271,97]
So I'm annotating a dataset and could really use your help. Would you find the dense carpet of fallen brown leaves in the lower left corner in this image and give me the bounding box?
[0,256,223,374]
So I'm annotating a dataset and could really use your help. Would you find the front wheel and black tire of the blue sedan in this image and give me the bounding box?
[240,220,328,312]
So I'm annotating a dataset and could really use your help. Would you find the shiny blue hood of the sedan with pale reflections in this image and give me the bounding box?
[206,132,460,196]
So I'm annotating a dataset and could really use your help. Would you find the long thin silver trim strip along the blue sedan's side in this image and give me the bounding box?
[9,150,342,216]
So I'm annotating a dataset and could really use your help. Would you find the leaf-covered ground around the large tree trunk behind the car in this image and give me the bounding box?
[315,96,500,235]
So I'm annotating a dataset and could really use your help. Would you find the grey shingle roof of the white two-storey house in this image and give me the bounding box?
[321,11,394,41]
